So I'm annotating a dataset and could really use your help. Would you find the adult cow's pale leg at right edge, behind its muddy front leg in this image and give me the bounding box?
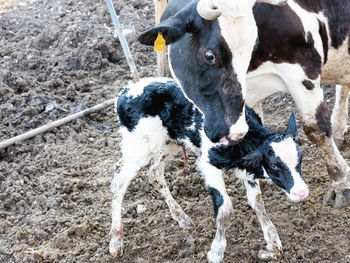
[331,85,350,147]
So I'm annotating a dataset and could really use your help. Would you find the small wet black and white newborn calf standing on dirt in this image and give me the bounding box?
[109,78,308,262]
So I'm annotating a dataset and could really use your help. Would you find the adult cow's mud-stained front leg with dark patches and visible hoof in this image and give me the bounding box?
[289,80,350,207]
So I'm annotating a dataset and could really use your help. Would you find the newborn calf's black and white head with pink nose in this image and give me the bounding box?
[246,113,309,202]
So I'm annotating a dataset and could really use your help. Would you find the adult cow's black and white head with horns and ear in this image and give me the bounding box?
[138,0,285,143]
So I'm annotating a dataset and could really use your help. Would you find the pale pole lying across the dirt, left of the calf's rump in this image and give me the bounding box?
[0,99,115,150]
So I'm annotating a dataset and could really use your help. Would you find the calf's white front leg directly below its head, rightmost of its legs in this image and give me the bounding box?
[243,180,282,260]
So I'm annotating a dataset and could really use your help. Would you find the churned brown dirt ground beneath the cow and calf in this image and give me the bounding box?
[0,0,350,263]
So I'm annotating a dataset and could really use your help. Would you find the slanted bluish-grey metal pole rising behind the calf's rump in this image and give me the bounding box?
[106,0,140,81]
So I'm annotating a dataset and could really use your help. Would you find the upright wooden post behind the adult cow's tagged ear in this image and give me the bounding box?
[155,0,170,77]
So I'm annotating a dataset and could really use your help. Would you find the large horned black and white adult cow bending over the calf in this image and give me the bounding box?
[138,0,350,207]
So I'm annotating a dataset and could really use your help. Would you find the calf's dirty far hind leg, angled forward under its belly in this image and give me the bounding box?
[148,153,193,227]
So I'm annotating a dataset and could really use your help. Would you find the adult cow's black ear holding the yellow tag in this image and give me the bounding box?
[137,16,186,46]
